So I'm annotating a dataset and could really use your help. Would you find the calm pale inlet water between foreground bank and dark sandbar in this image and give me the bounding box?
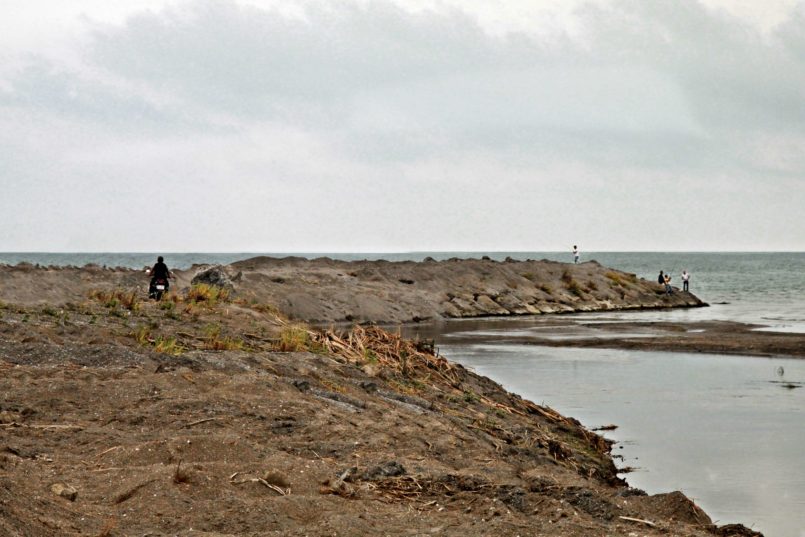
[440,340,805,537]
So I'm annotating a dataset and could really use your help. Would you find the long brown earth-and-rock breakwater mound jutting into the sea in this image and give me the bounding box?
[209,257,706,323]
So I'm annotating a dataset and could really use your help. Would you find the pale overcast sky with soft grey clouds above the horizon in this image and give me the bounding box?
[0,0,805,252]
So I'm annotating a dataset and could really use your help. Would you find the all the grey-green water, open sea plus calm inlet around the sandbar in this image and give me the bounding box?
[0,251,805,537]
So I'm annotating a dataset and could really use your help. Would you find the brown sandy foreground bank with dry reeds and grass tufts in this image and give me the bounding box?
[0,260,768,537]
